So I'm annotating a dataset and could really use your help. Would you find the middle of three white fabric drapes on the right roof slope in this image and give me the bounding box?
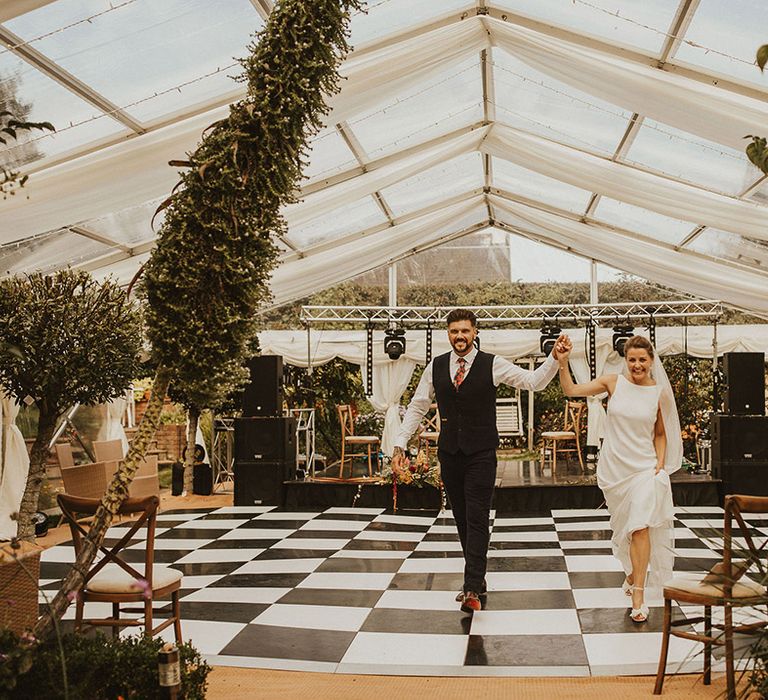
[481,124,768,240]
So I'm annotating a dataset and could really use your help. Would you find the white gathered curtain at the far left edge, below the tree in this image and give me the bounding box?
[0,390,29,540]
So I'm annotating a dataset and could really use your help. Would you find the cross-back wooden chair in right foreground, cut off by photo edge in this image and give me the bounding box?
[653,496,768,700]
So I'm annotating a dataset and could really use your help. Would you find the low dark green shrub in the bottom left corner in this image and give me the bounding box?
[0,630,211,700]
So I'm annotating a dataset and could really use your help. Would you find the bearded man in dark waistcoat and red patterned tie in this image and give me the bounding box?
[392,309,566,613]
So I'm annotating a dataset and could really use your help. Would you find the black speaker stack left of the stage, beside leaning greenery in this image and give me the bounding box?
[234,355,296,506]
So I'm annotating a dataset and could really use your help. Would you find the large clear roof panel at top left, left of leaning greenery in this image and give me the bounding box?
[8,0,263,122]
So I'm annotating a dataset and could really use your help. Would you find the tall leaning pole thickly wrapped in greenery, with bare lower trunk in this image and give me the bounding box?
[35,0,361,636]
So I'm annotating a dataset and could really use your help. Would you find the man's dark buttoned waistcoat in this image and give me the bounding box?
[432,351,499,455]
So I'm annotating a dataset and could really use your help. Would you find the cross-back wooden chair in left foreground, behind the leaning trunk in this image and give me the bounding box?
[58,494,182,643]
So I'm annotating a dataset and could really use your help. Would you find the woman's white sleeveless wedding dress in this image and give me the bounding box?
[597,375,679,586]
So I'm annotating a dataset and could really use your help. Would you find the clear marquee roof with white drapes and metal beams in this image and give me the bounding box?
[0,0,768,315]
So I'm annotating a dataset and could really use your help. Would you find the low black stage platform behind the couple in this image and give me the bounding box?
[285,453,721,513]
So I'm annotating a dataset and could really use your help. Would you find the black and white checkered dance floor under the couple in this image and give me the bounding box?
[41,506,768,676]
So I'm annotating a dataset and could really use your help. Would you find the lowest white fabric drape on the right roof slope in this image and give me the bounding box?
[490,195,768,314]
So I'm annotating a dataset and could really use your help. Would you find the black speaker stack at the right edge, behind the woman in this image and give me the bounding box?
[711,352,768,496]
